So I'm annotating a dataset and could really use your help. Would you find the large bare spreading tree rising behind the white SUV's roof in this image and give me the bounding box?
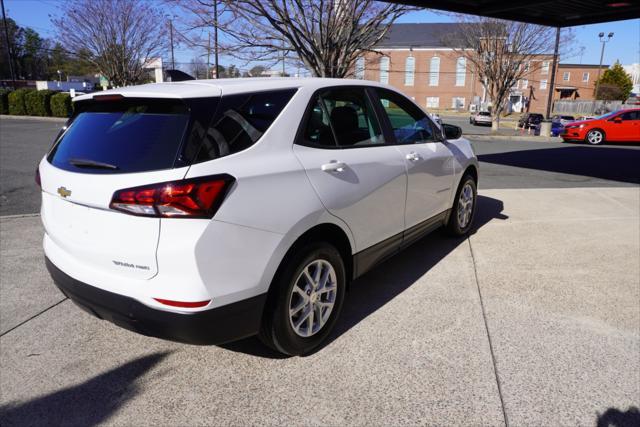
[172,0,413,77]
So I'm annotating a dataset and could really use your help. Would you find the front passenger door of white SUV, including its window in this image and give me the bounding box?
[375,88,454,229]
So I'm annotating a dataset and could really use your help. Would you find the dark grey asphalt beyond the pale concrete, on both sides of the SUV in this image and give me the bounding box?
[0,116,640,215]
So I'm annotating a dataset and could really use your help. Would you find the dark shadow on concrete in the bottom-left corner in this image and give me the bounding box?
[0,352,169,426]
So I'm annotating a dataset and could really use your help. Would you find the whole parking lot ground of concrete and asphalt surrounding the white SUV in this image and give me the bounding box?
[0,118,640,426]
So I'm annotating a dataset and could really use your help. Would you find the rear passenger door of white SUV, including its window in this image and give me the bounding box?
[294,87,407,252]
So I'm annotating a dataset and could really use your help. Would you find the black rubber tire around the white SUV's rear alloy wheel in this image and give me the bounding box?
[259,242,346,356]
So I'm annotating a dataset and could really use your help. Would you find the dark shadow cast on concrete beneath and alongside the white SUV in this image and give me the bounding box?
[221,195,508,358]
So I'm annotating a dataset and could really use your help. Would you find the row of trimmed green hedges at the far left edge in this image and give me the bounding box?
[0,89,73,117]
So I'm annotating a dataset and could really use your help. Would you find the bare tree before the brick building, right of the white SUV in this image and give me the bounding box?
[445,15,569,131]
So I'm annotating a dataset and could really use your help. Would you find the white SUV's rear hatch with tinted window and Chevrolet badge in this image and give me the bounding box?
[39,95,215,279]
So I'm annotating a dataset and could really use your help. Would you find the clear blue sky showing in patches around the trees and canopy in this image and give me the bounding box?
[5,0,640,71]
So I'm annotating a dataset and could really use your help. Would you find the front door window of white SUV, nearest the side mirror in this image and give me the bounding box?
[376,89,437,144]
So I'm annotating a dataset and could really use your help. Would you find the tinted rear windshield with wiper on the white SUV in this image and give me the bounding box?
[48,98,189,173]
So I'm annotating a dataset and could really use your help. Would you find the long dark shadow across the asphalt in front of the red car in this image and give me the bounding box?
[478,145,640,184]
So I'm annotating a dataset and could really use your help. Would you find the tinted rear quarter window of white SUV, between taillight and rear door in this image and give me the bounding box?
[194,89,296,163]
